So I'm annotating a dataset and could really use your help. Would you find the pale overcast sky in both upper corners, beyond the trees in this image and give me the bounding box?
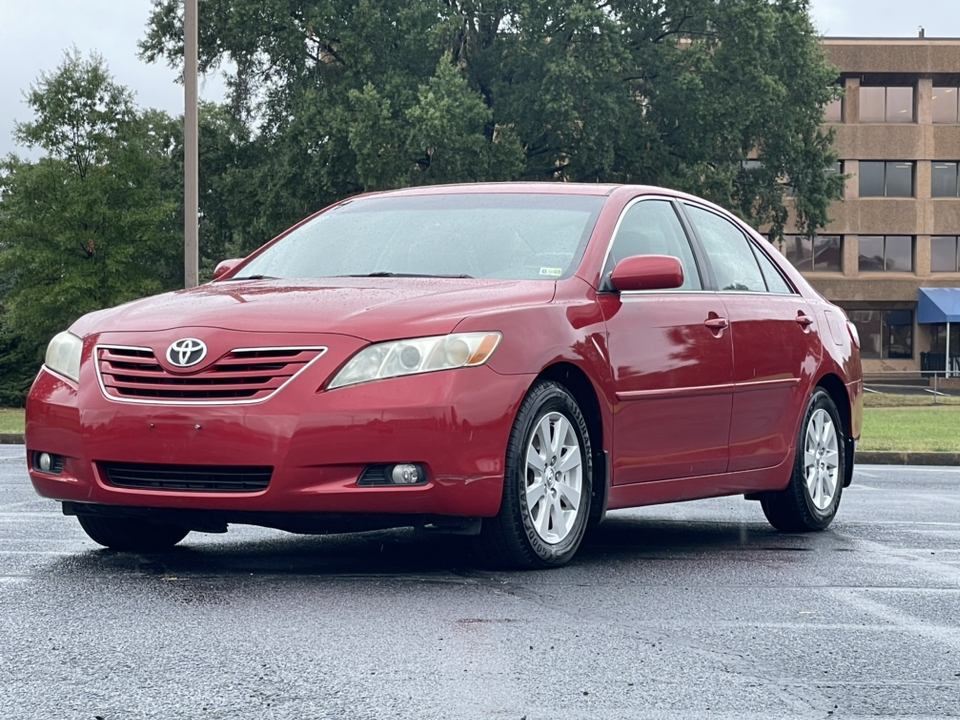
[0,0,960,156]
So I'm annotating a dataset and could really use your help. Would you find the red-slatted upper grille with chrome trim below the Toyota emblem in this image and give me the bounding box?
[96,345,326,404]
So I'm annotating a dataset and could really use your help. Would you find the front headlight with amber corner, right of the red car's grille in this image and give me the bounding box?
[327,333,501,390]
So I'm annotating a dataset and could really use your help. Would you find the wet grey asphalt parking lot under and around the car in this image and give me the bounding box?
[0,445,960,720]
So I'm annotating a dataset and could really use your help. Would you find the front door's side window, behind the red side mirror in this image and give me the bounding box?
[603,200,703,290]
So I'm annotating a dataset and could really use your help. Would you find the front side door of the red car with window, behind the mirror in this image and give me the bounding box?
[598,199,733,485]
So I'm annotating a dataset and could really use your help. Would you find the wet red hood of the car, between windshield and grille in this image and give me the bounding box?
[71,277,556,342]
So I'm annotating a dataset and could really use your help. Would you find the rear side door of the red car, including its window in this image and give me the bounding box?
[684,203,822,472]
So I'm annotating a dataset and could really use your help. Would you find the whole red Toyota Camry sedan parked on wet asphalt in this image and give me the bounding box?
[26,183,863,568]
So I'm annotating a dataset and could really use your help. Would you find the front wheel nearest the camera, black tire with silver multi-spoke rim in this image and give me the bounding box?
[477,380,593,569]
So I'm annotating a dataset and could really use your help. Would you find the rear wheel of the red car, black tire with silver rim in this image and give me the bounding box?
[760,388,846,532]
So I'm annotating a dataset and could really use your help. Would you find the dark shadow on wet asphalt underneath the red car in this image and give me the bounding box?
[45,516,847,581]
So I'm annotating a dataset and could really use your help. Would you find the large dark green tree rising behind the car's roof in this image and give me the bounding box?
[141,0,841,240]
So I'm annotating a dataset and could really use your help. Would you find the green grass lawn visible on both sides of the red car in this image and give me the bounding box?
[0,395,960,452]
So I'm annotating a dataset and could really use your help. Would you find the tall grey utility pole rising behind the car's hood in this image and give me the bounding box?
[183,0,200,288]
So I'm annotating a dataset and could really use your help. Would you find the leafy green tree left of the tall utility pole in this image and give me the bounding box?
[0,50,183,400]
